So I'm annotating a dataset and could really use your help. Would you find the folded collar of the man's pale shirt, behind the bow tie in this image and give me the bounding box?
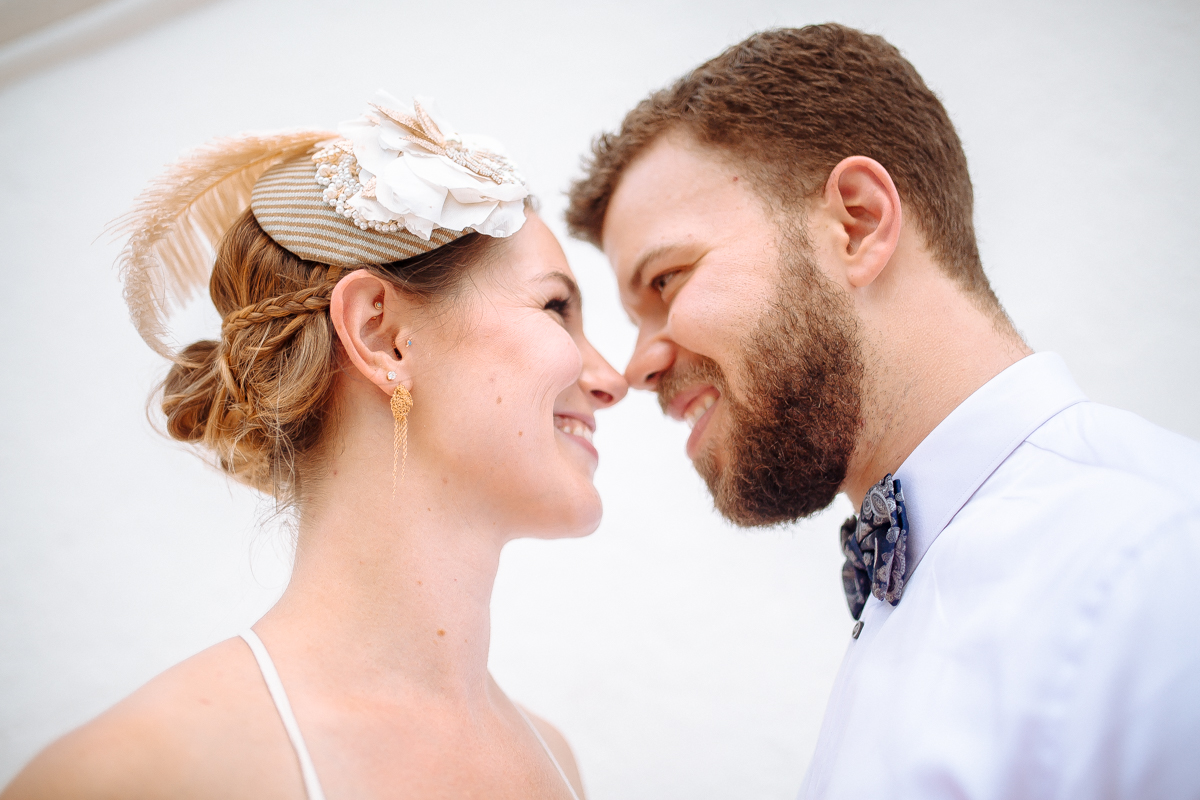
[895,353,1087,577]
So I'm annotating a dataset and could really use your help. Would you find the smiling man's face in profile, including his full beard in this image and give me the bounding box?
[602,136,863,525]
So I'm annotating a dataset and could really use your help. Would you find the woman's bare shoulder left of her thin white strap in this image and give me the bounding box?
[2,638,304,800]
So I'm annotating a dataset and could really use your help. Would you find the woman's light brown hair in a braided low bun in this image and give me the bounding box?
[161,210,506,506]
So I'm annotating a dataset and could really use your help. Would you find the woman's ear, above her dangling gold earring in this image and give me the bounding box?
[329,270,415,395]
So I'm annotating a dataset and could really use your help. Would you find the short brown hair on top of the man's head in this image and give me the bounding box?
[566,23,998,308]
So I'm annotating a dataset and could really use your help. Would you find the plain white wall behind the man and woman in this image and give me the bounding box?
[0,0,1200,800]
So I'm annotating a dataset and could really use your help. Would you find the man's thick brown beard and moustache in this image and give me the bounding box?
[658,242,863,527]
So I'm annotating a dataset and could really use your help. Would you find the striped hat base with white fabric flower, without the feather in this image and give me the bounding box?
[251,92,529,266]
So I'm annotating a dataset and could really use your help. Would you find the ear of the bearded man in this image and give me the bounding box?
[823,156,904,289]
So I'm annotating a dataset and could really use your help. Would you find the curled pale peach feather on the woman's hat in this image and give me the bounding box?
[107,130,336,359]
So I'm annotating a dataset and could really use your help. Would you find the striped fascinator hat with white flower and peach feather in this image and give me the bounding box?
[114,92,529,359]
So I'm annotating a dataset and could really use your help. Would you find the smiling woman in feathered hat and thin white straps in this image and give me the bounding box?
[4,97,626,800]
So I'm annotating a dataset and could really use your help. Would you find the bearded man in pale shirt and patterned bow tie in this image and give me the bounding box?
[568,24,1200,800]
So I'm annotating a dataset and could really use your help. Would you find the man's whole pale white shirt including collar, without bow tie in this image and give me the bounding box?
[800,353,1200,800]
